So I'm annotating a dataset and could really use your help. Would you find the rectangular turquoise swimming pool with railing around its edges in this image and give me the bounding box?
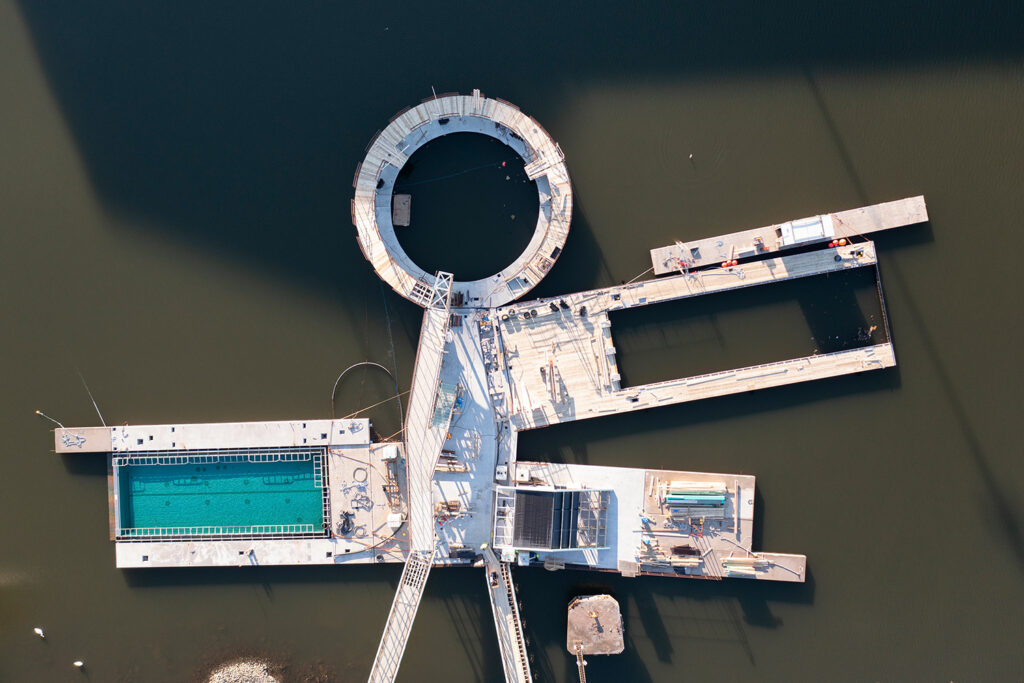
[114,449,325,539]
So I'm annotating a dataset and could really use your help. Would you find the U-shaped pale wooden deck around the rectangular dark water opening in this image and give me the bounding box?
[496,242,896,429]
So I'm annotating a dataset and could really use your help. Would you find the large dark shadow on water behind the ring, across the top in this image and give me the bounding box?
[18,1,1022,308]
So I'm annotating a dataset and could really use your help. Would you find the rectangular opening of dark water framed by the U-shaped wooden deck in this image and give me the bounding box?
[609,267,889,388]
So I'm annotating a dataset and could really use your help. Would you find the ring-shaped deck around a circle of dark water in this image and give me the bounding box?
[351,90,572,308]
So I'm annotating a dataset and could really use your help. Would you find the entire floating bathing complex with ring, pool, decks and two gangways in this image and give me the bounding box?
[48,90,928,682]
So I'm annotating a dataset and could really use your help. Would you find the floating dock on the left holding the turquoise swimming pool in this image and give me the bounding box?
[54,420,409,568]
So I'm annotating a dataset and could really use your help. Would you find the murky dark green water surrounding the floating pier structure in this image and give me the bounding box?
[0,0,1024,681]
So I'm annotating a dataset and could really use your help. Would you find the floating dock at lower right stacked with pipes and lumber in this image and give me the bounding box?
[494,461,807,583]
